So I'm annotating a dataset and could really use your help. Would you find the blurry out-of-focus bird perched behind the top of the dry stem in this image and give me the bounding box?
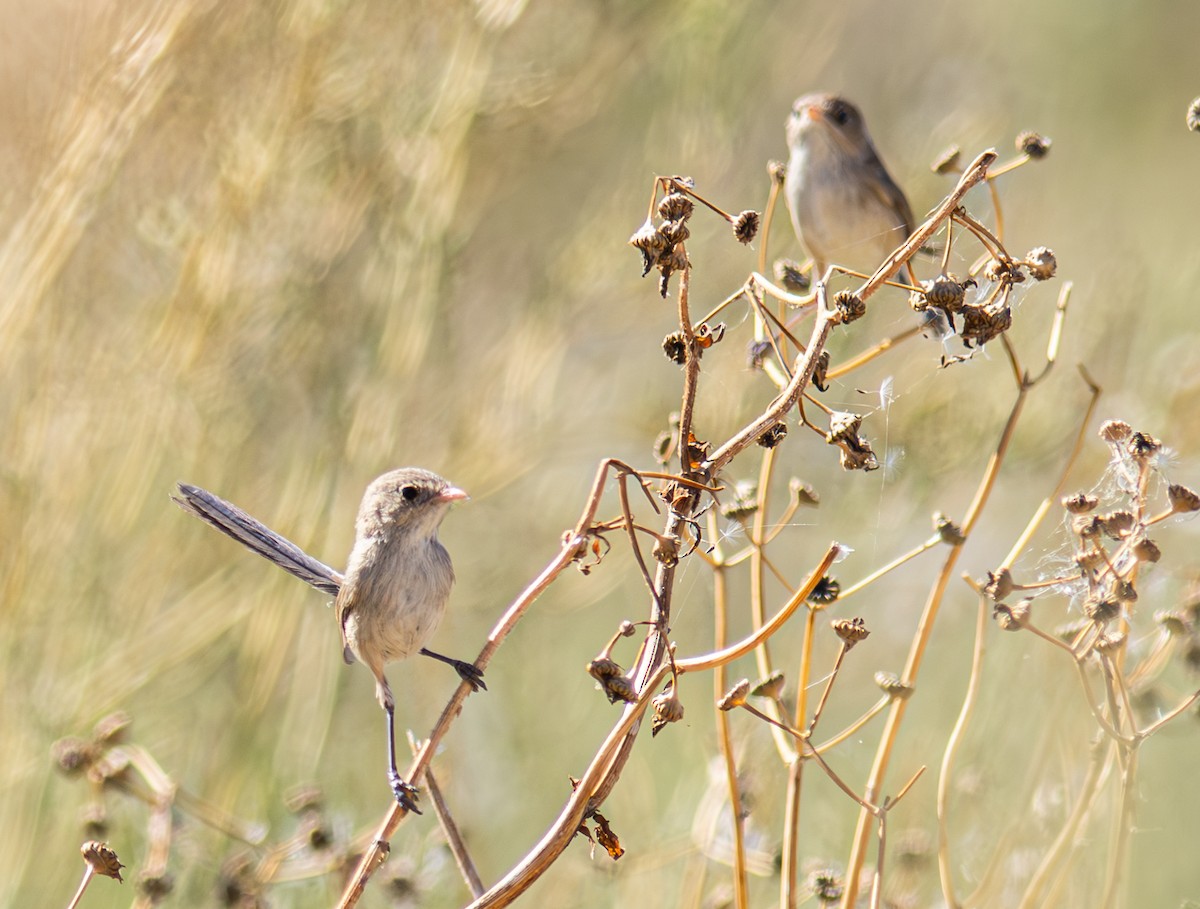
[784,95,913,283]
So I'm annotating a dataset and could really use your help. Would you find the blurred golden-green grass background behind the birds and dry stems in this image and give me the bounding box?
[7,0,1200,907]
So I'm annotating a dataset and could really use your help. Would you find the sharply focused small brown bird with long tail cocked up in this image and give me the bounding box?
[175,468,487,813]
